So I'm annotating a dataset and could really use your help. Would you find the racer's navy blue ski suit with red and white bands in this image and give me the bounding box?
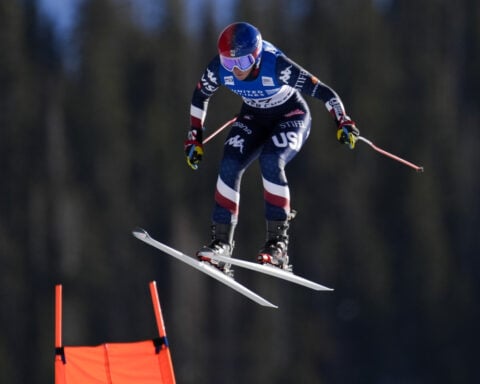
[190,41,348,224]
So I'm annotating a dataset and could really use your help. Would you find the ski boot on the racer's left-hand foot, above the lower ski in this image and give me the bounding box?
[197,224,235,277]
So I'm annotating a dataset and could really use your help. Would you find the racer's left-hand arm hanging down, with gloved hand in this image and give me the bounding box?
[184,56,220,169]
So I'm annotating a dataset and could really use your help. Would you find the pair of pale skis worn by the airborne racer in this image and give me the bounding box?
[132,228,332,308]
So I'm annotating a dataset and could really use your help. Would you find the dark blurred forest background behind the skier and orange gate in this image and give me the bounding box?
[0,0,480,384]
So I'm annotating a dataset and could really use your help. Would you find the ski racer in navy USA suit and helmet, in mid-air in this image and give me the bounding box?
[184,22,359,274]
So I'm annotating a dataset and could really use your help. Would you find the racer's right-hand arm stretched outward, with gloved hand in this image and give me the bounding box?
[276,55,360,149]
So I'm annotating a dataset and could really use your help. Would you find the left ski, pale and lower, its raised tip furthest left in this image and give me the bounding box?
[132,228,278,308]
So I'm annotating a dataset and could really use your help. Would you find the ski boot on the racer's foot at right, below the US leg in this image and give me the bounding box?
[257,211,296,272]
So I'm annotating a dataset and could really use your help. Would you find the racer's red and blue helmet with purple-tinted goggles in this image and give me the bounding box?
[217,22,262,71]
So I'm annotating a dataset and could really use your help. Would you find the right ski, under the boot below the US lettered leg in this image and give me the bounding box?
[206,256,333,291]
